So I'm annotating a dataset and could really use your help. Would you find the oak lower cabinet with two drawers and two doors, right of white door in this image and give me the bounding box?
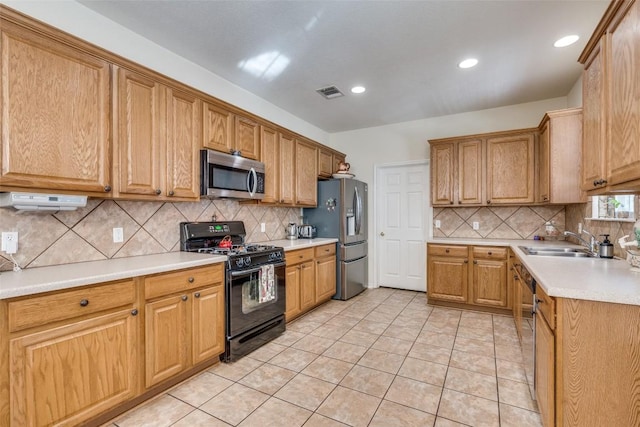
[427,244,511,310]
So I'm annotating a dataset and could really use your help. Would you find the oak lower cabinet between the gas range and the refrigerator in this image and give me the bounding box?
[285,243,336,321]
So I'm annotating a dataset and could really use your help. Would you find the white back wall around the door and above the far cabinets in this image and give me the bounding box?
[329,97,567,287]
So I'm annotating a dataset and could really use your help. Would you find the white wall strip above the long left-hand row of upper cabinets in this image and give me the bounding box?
[0,0,329,144]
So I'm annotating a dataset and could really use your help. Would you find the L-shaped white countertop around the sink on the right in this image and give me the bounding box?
[428,238,640,305]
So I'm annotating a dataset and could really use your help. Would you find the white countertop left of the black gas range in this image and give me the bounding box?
[0,252,227,299]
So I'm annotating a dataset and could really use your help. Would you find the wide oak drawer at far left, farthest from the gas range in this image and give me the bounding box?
[9,280,136,332]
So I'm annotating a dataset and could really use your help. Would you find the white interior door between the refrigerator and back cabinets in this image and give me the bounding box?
[376,162,429,292]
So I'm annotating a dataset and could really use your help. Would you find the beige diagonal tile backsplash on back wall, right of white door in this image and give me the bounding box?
[433,206,565,239]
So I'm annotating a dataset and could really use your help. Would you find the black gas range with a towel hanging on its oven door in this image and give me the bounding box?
[180,221,286,362]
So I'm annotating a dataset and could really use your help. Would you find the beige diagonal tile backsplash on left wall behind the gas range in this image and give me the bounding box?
[0,199,301,271]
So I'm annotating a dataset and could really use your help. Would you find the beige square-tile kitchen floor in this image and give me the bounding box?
[108,288,541,427]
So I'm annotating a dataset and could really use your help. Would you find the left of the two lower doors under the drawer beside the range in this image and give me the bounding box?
[145,295,189,388]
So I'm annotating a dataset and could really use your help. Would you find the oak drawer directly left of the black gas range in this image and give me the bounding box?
[144,264,224,299]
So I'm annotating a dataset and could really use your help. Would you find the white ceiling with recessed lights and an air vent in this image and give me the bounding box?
[80,0,609,133]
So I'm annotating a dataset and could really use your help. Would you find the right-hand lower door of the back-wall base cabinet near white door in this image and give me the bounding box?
[471,259,509,307]
